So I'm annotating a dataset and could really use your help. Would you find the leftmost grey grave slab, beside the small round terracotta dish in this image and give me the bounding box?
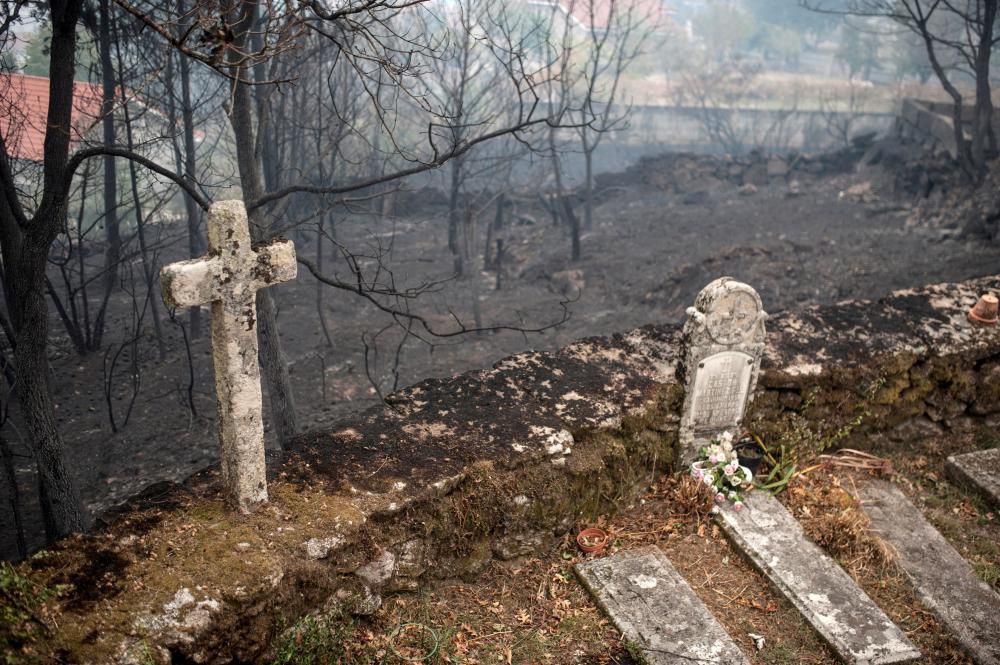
[576,545,749,665]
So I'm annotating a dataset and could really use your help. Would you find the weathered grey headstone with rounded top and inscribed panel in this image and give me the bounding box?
[679,277,767,466]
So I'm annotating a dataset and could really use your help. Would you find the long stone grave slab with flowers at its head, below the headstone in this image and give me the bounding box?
[719,491,920,665]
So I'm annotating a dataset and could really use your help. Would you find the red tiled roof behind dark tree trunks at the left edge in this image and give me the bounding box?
[0,74,101,162]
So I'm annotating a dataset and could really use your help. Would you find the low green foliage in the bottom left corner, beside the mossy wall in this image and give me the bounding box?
[0,562,59,665]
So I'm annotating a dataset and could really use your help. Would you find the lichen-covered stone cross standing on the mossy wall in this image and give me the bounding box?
[160,201,296,513]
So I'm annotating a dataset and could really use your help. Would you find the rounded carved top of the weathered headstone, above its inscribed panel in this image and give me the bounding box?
[688,277,767,346]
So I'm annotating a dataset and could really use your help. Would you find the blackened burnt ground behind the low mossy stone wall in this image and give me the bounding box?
[0,147,1000,558]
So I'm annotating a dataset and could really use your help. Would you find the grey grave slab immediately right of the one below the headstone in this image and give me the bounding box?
[858,482,1000,665]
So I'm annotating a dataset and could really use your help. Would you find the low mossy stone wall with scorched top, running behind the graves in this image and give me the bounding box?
[9,277,1000,663]
